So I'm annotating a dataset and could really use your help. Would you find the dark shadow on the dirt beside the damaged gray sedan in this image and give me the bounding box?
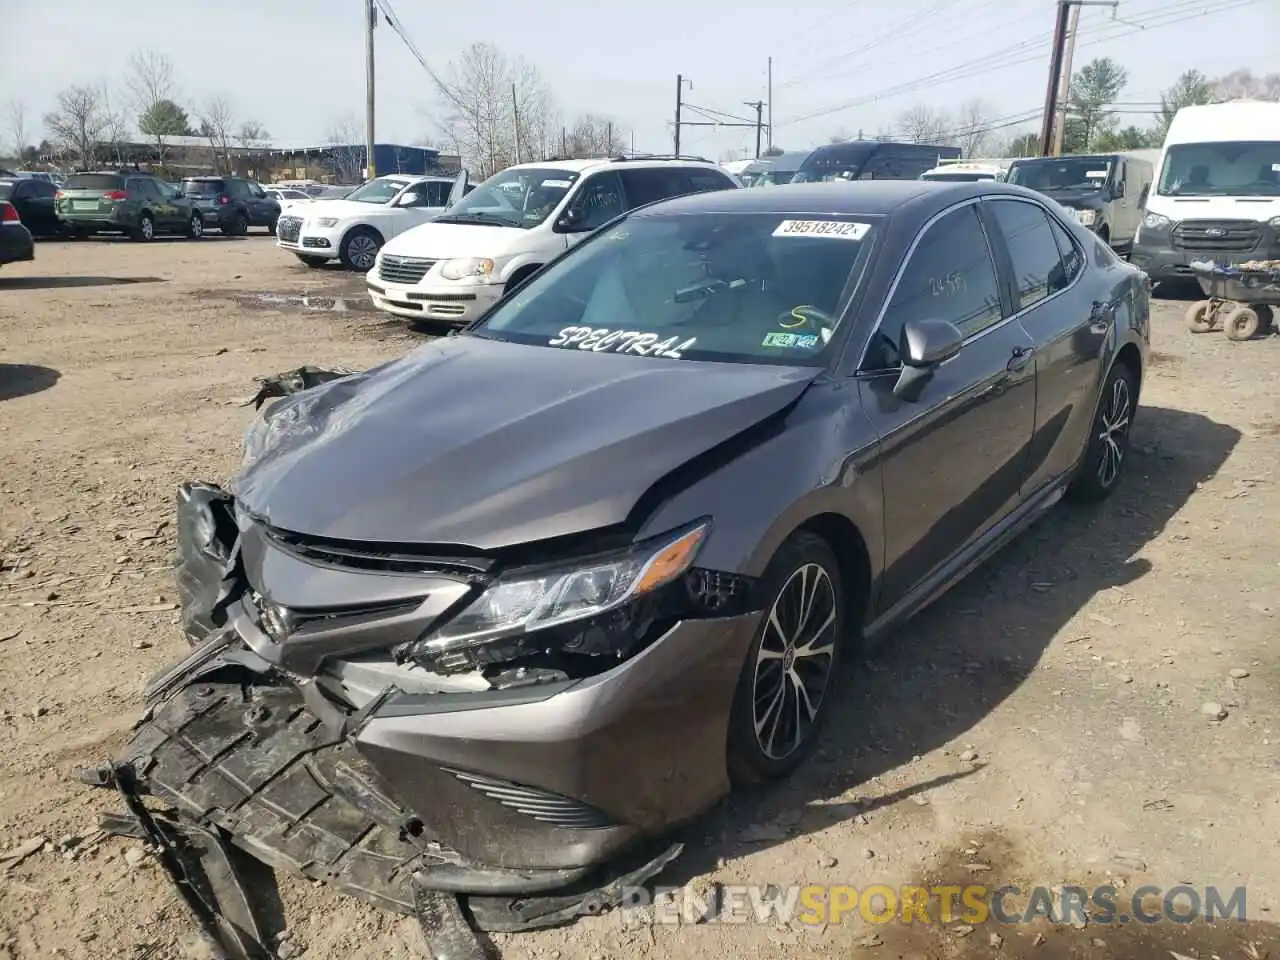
[658,407,1240,884]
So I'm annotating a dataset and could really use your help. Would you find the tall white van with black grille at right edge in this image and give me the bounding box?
[1130,100,1280,283]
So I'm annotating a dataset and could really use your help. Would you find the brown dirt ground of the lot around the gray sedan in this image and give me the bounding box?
[0,237,1280,960]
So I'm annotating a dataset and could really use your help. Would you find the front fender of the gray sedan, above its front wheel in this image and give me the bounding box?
[641,380,883,581]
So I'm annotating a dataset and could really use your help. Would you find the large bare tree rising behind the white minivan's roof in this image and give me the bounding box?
[435,44,556,178]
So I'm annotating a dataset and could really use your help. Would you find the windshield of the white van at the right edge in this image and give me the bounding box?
[1157,141,1280,197]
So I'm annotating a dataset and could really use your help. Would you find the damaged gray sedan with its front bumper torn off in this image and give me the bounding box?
[90,182,1148,957]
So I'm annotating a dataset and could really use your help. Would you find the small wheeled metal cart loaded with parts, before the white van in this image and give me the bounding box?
[1187,260,1280,340]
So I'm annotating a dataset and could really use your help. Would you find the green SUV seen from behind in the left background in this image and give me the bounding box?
[55,173,205,241]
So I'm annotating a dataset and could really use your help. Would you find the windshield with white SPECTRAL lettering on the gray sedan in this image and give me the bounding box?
[470,214,874,366]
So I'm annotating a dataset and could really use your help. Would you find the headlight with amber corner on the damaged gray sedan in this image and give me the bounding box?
[411,521,709,657]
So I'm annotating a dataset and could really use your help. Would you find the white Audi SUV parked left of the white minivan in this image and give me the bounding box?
[275,172,467,273]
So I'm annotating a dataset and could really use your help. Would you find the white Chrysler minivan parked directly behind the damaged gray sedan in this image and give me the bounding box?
[367,157,739,324]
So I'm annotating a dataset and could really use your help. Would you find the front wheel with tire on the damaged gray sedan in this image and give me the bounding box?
[727,531,846,785]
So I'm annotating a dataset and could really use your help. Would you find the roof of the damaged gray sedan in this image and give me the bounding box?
[629,180,1043,216]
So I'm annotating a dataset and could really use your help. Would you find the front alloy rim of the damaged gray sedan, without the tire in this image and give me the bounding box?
[751,563,837,760]
